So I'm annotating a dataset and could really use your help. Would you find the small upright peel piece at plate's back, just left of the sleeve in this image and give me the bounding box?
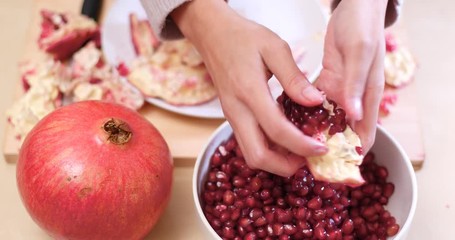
[129,13,160,56]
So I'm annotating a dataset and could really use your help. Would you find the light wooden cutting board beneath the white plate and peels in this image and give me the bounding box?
[3,0,425,169]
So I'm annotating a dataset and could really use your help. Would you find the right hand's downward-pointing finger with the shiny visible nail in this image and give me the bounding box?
[340,40,372,121]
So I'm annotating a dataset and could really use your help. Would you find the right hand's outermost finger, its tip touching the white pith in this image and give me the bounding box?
[354,51,384,152]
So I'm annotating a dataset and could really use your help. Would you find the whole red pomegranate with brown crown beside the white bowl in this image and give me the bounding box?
[17,101,173,239]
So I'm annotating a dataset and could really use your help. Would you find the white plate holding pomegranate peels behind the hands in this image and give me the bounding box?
[101,0,327,118]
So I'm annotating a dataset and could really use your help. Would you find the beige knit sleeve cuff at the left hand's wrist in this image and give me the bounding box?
[141,0,190,40]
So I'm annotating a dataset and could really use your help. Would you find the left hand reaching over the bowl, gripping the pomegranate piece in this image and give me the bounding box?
[172,0,327,176]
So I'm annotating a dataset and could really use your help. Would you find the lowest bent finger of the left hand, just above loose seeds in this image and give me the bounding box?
[225,99,305,177]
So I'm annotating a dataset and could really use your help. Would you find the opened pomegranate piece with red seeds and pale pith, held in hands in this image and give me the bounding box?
[278,92,364,186]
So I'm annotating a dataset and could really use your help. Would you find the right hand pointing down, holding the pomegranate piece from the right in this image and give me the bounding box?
[316,0,387,151]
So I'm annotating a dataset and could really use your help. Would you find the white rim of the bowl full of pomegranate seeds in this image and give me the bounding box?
[192,121,418,239]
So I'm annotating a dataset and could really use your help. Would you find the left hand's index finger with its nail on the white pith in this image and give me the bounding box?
[239,76,327,156]
